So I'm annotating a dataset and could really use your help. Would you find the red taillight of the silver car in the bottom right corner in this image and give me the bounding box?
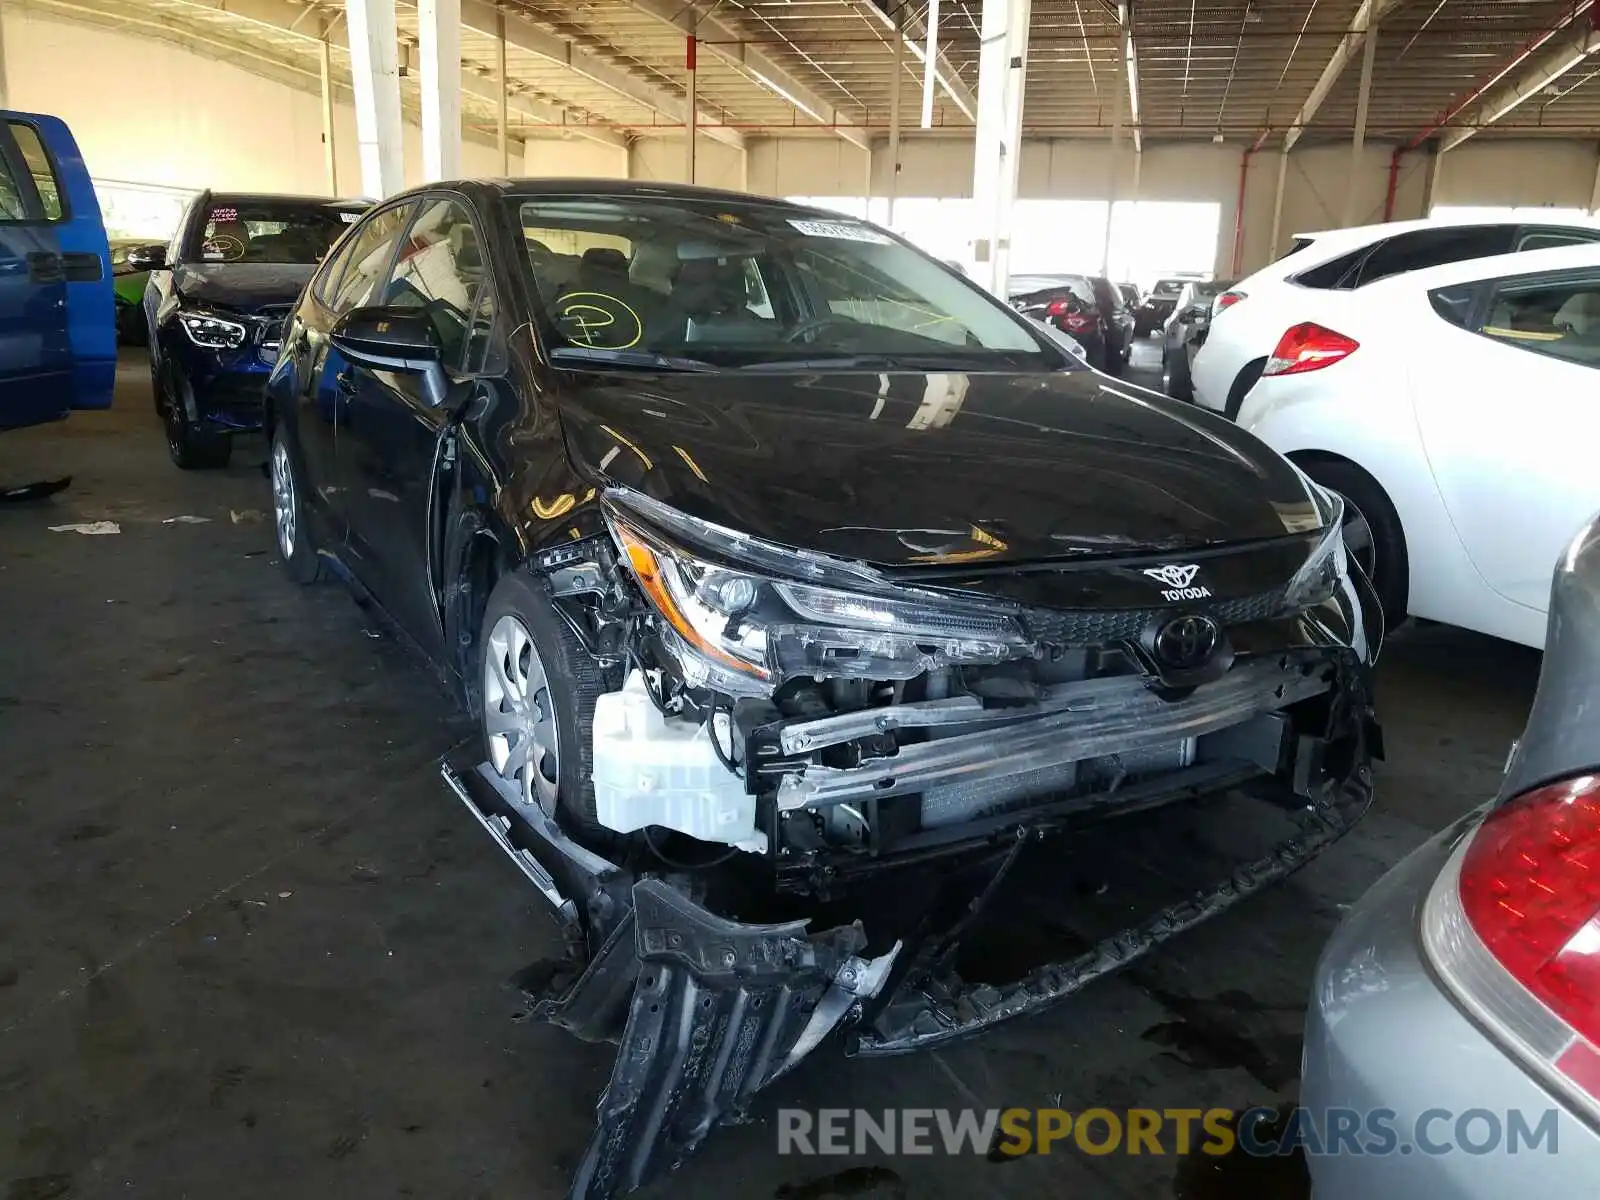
[1458,776,1600,1045]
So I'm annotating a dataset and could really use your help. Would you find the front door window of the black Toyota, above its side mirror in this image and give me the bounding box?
[382,200,486,365]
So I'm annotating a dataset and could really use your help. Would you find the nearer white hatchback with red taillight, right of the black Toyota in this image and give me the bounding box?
[1222,243,1600,646]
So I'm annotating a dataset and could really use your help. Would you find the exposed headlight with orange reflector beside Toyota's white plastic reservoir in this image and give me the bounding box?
[606,496,1027,696]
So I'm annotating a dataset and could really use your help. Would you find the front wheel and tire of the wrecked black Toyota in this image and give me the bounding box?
[478,571,621,842]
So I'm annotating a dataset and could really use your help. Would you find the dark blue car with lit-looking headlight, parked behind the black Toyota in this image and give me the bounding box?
[130,192,366,470]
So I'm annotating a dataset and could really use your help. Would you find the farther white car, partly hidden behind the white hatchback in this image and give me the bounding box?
[1192,218,1600,416]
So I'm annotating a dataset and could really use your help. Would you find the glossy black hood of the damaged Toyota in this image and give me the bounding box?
[560,370,1315,566]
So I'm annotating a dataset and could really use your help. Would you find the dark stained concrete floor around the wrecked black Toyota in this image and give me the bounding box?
[0,346,1538,1200]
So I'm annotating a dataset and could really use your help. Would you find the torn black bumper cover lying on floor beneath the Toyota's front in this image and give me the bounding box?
[443,668,1376,1200]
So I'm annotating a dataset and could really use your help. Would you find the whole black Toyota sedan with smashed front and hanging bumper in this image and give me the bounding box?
[269,181,1382,1197]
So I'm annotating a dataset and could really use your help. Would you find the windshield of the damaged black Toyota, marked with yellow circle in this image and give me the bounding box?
[509,195,1064,371]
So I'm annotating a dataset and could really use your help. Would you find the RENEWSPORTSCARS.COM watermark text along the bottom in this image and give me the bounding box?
[778,1107,1560,1157]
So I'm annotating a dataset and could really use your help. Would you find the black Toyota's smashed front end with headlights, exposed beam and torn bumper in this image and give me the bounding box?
[445,491,1381,1200]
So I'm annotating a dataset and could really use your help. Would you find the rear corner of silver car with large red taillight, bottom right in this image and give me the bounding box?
[1301,517,1600,1200]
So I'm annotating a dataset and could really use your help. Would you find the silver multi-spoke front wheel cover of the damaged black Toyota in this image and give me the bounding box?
[483,613,558,816]
